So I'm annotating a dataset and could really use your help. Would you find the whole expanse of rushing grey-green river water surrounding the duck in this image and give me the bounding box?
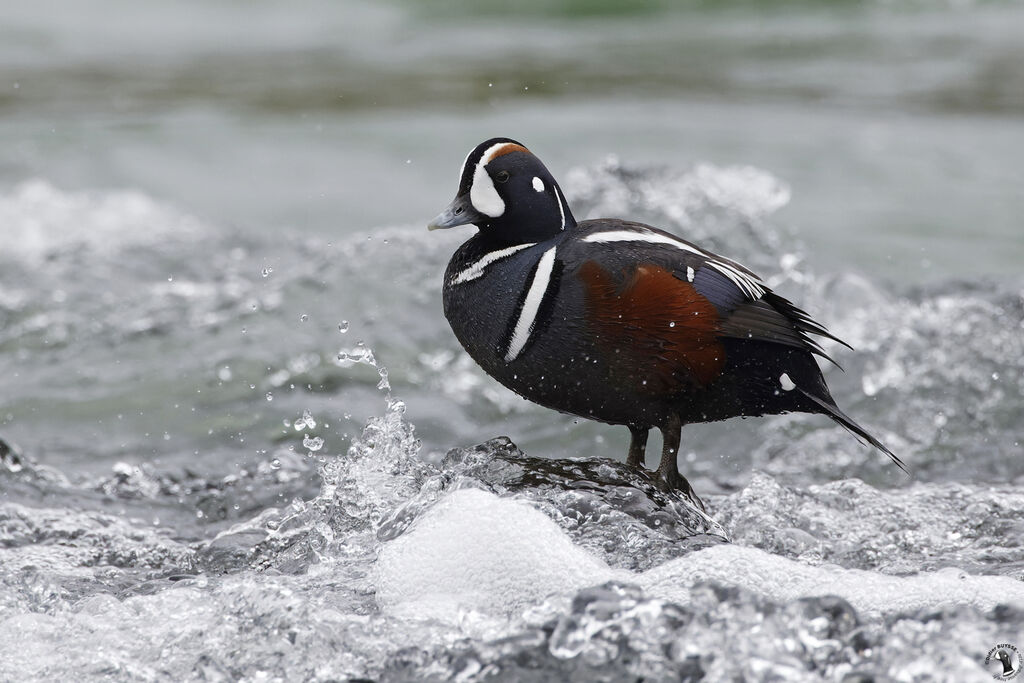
[0,0,1024,681]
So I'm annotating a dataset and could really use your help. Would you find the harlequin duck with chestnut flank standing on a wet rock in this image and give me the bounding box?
[428,137,903,504]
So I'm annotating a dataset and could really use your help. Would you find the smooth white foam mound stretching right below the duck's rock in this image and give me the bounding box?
[377,489,1024,621]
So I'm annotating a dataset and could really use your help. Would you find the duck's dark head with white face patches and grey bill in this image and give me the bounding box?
[427,137,575,245]
